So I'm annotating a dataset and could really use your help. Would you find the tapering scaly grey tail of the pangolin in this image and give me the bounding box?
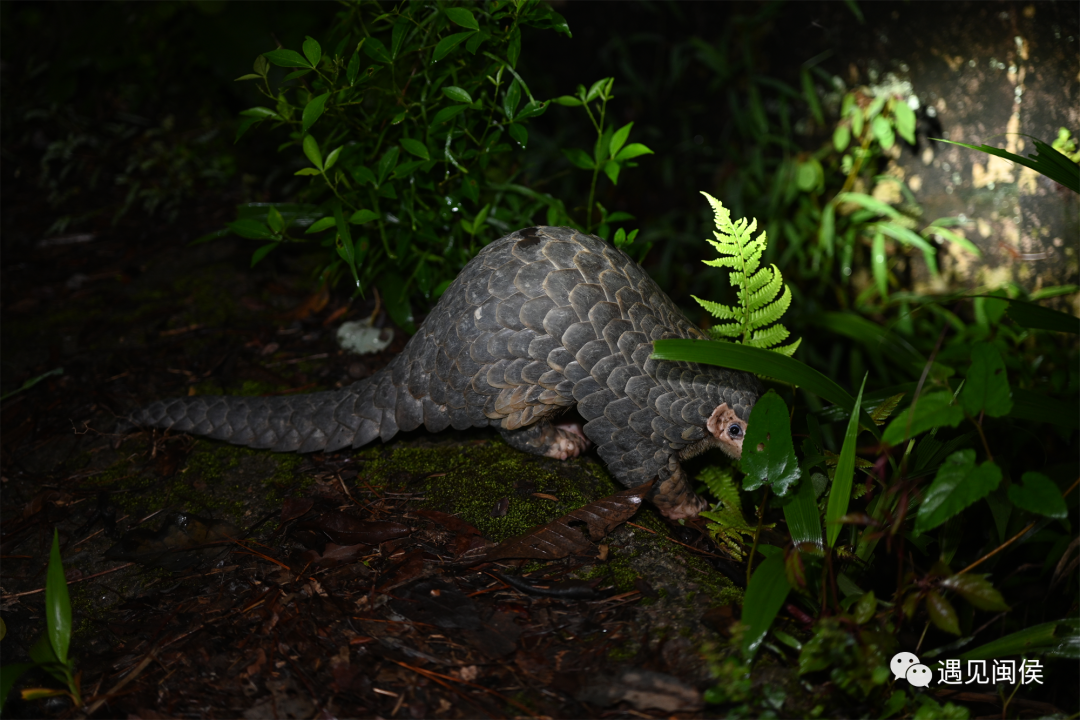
[125,367,411,452]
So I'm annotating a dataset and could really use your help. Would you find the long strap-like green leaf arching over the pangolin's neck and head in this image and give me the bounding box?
[651,340,881,437]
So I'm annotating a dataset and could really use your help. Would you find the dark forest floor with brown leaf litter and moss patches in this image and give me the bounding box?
[0,199,1054,720]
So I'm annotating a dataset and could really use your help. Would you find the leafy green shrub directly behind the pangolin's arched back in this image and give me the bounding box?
[229,0,652,306]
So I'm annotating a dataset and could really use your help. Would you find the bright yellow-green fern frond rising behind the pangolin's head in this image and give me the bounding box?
[693,192,801,356]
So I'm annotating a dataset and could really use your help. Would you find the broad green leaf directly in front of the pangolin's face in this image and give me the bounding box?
[741,390,801,495]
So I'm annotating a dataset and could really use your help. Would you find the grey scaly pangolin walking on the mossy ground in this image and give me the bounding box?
[129,227,761,519]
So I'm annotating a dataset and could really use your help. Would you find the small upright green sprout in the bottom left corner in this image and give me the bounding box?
[0,529,82,711]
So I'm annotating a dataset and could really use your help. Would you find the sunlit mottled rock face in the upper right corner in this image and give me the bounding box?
[837,0,1080,304]
